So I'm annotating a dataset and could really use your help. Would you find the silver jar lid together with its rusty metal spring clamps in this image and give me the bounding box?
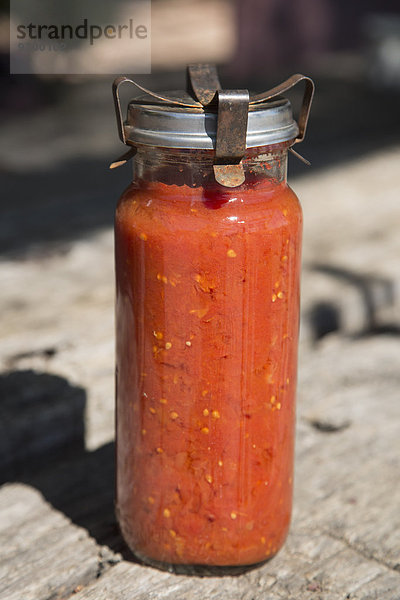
[112,64,314,187]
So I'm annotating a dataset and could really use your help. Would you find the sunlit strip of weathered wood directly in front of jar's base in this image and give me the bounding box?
[72,531,400,600]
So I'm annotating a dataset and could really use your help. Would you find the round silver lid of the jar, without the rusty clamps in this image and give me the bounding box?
[125,92,299,150]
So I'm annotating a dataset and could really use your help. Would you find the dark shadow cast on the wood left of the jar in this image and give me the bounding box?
[0,370,133,560]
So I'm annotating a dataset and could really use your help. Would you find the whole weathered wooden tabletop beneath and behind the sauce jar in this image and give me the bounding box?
[0,71,400,600]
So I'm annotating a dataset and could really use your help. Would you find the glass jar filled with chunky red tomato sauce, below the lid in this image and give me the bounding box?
[115,149,302,566]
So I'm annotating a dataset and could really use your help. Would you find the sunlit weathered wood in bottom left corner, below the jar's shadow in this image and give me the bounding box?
[0,484,115,600]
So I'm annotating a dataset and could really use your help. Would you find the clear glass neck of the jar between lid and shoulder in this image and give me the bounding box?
[134,143,290,187]
